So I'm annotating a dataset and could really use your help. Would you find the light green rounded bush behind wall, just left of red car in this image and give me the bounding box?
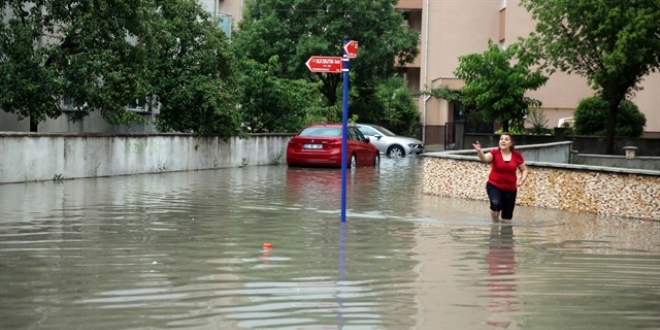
[239,55,326,133]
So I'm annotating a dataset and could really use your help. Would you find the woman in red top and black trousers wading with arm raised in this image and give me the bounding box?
[472,133,527,222]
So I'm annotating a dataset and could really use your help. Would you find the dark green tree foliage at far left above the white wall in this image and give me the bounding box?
[0,0,153,123]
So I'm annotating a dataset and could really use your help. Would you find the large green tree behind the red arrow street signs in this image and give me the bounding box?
[233,0,419,118]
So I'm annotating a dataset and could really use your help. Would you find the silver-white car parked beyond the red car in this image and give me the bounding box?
[355,124,424,157]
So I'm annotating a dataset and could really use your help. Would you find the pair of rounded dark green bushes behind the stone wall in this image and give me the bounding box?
[574,96,646,137]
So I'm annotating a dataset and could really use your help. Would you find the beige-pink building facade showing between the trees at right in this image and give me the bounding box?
[397,0,660,144]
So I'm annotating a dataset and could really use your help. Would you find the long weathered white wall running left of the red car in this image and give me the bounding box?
[0,132,292,183]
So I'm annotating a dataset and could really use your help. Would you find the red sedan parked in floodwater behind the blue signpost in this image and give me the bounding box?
[286,124,380,169]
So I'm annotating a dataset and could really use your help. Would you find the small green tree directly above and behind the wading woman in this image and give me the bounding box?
[454,40,548,132]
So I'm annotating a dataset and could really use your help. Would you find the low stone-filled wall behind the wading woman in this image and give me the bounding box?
[422,157,660,221]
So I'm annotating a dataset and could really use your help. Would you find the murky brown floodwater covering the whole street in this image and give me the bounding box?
[0,158,660,330]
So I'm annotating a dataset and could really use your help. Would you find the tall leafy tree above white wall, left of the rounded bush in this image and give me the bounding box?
[148,0,242,140]
